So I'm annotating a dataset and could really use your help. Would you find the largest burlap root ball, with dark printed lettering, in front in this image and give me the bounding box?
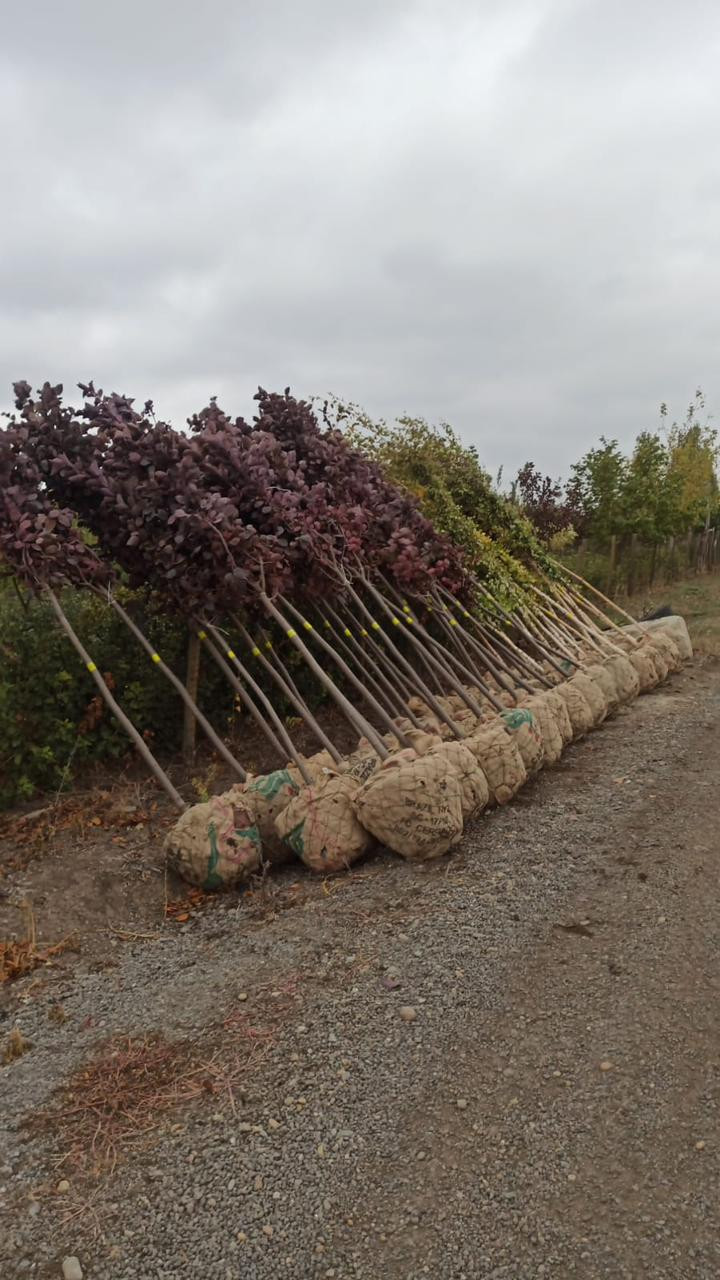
[354,745,462,861]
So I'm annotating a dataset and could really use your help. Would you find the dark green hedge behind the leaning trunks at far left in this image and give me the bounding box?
[0,585,233,808]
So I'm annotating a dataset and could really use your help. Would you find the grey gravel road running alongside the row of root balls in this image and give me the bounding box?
[0,660,720,1280]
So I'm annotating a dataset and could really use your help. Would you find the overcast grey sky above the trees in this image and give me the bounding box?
[0,0,720,474]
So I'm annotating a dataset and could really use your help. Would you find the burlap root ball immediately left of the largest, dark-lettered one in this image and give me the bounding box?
[275,773,372,872]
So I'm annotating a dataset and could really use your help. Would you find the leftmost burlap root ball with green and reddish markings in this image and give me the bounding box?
[164,787,263,888]
